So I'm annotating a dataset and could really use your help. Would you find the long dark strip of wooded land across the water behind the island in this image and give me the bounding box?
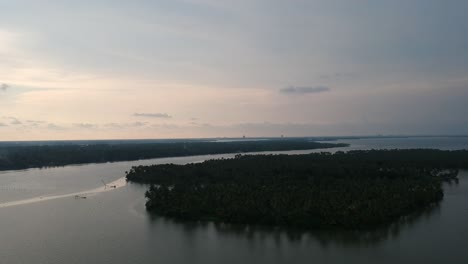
[0,139,347,170]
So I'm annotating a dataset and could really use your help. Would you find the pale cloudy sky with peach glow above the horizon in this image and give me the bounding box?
[0,0,468,141]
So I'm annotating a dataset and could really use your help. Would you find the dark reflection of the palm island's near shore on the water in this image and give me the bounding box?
[147,199,440,248]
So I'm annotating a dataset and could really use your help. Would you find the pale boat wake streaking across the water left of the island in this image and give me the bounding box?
[0,178,127,208]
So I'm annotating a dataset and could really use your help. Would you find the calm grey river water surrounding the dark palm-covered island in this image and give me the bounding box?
[0,138,468,264]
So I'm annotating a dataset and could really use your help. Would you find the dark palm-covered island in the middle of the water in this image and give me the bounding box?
[127,149,468,229]
